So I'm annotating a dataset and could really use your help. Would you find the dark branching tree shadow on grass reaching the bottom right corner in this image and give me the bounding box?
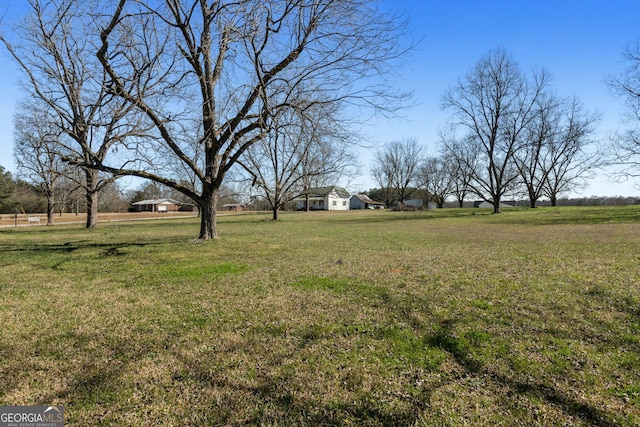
[185,295,618,427]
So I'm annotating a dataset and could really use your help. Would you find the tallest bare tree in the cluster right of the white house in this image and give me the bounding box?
[442,49,547,213]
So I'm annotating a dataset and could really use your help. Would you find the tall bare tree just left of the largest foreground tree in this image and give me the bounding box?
[0,0,145,228]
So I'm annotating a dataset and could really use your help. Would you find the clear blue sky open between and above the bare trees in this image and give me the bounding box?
[0,0,640,196]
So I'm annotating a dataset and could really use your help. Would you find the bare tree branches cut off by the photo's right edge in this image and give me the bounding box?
[608,39,640,180]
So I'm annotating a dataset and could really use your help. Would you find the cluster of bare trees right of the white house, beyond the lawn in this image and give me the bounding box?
[372,49,604,213]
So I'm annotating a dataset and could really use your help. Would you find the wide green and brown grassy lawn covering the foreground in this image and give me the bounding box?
[0,207,640,426]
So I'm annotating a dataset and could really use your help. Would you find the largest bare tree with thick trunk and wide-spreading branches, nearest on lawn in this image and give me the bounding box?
[90,0,406,240]
